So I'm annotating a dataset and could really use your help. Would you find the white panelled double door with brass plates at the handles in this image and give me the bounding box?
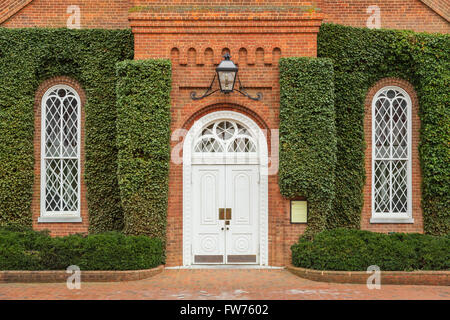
[192,164,259,264]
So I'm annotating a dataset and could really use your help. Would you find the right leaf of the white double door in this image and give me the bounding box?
[226,165,259,263]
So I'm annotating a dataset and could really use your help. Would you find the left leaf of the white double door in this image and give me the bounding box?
[192,166,225,263]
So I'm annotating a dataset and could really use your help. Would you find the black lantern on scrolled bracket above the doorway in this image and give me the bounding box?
[191,52,262,100]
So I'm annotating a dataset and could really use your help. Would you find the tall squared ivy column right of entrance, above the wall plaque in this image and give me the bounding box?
[279,58,336,235]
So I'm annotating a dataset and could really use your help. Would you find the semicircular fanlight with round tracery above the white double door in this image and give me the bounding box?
[194,120,256,153]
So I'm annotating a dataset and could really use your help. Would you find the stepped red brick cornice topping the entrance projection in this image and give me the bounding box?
[128,5,323,34]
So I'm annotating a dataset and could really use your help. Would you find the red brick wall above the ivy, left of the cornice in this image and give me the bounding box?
[0,0,129,29]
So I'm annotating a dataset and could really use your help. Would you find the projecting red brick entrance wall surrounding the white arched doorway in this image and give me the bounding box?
[130,12,320,266]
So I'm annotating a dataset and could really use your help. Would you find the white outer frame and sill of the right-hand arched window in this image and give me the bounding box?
[370,86,414,223]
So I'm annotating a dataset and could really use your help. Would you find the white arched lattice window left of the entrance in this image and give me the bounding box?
[39,85,81,222]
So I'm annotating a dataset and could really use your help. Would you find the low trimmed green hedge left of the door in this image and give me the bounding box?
[0,229,164,271]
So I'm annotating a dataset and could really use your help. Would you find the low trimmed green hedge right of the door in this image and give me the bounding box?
[291,228,450,271]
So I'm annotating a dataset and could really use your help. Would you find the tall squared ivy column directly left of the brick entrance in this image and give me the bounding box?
[117,60,172,239]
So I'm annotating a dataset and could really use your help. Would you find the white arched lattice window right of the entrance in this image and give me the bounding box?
[371,87,412,223]
